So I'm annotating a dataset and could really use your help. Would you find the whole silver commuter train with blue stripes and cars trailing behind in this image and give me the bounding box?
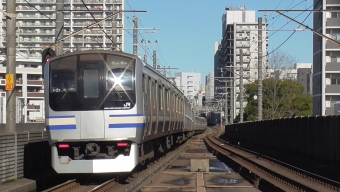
[42,49,207,173]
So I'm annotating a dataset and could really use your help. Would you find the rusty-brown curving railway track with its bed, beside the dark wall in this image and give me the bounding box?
[205,133,340,191]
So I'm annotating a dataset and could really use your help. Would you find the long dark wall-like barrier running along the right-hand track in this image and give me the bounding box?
[225,115,340,165]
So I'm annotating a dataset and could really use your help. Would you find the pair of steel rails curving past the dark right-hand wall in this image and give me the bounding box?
[205,135,339,191]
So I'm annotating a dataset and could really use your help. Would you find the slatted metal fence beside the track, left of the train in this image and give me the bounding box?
[0,131,48,182]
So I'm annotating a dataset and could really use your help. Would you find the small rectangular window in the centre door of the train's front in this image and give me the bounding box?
[83,69,99,98]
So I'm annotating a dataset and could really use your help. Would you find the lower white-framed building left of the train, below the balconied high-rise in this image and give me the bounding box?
[0,60,45,123]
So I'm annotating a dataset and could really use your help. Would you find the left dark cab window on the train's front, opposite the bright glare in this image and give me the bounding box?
[50,56,77,93]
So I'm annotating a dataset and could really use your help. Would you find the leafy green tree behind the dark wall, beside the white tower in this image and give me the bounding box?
[245,78,313,121]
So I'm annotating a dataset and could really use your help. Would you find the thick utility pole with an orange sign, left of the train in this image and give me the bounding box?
[5,0,17,133]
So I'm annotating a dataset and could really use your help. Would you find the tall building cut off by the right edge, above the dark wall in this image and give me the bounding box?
[313,0,340,115]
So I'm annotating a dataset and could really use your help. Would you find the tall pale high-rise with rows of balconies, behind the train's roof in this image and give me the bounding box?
[0,0,124,61]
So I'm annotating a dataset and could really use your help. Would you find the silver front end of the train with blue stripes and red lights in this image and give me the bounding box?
[43,51,144,173]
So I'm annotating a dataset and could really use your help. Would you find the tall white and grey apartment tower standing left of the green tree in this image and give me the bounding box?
[220,7,268,122]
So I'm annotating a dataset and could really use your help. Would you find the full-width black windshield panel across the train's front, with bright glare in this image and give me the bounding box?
[49,54,136,111]
